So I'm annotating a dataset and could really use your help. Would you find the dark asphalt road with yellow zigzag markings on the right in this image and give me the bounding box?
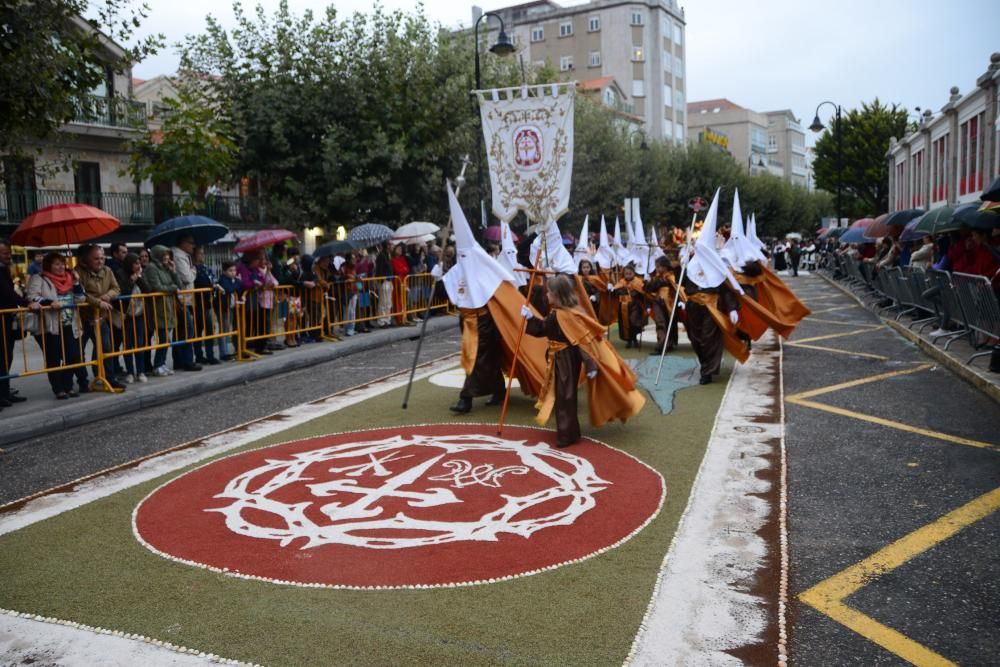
[784,276,1000,665]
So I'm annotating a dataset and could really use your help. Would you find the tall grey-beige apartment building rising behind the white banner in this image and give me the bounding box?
[482,0,687,143]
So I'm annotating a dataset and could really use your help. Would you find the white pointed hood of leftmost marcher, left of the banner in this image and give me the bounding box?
[443,183,514,308]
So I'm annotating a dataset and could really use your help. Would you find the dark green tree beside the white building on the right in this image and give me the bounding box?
[813,98,909,218]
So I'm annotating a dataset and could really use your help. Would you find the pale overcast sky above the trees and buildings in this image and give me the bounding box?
[134,0,1000,144]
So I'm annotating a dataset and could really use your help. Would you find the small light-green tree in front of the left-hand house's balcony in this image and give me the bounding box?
[121,83,237,198]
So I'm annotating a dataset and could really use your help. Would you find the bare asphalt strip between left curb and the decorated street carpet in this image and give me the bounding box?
[0,326,460,504]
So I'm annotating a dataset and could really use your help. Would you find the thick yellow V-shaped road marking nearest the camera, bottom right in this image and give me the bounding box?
[799,489,1000,665]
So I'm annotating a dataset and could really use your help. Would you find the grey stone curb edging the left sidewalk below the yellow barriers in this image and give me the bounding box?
[0,316,455,445]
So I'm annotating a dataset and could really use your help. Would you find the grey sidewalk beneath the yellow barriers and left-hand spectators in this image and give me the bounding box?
[0,316,455,445]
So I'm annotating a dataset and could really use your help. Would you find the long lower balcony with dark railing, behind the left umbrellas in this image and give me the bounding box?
[0,188,258,230]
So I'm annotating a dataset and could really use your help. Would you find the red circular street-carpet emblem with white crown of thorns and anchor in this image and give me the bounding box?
[133,424,665,588]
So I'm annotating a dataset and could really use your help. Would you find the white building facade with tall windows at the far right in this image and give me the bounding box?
[886,53,1000,212]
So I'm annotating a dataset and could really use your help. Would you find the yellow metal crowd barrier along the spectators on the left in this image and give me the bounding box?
[0,274,449,393]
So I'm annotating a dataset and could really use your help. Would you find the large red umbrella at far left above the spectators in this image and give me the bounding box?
[10,204,122,248]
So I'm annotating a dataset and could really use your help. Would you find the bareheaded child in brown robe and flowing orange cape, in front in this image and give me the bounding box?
[521,275,646,447]
